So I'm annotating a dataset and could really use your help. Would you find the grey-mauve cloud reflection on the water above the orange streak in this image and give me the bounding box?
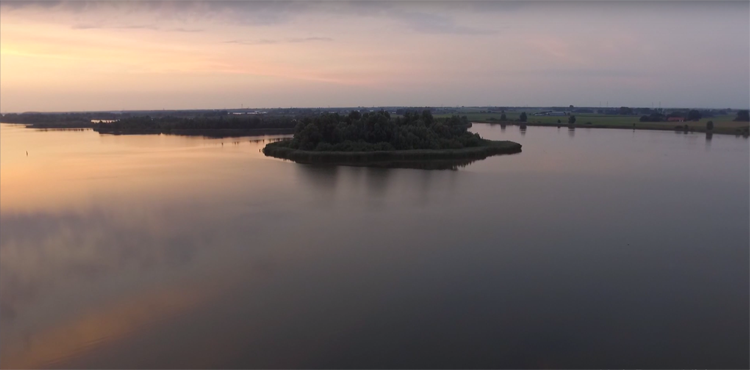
[0,210,200,322]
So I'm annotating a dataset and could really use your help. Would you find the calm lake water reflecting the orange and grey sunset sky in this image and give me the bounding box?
[0,125,750,370]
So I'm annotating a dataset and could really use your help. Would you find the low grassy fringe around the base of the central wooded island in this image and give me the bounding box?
[263,140,521,169]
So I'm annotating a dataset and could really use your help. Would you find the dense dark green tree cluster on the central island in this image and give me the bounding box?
[285,110,482,152]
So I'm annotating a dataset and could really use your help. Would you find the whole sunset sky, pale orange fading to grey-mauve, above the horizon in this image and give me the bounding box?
[0,0,750,112]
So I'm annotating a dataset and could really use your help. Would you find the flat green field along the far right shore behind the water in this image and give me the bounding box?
[435,110,750,135]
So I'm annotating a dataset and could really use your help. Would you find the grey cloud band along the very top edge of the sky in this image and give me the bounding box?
[8,0,750,35]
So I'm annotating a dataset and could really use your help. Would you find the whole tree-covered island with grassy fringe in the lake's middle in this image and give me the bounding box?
[263,110,521,169]
